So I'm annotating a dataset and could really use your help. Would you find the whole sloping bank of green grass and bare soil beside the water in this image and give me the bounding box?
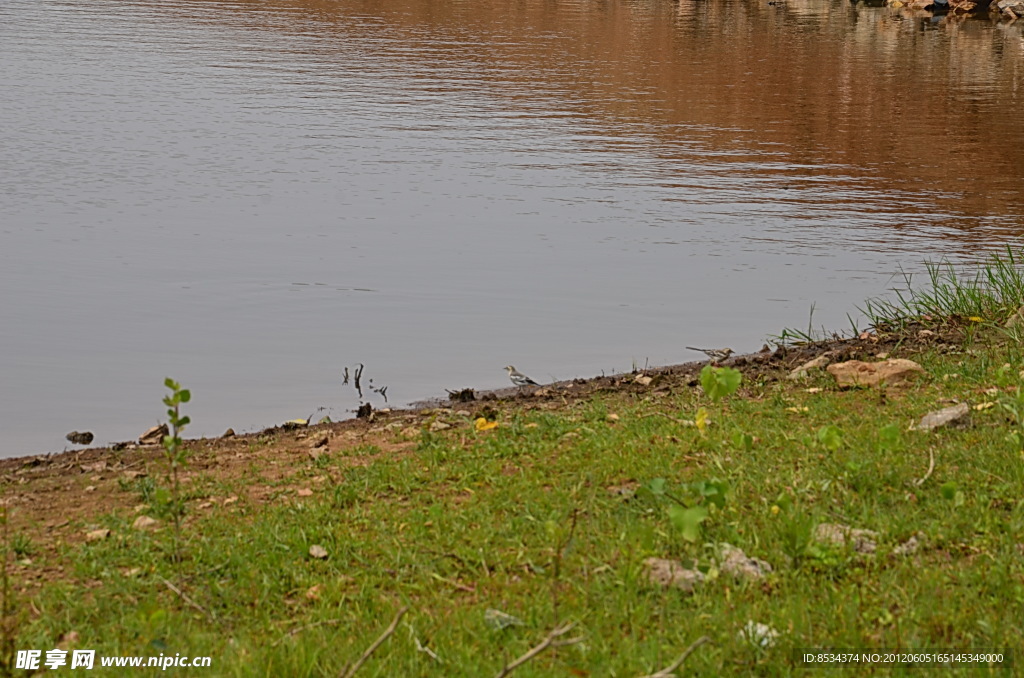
[3,253,1024,677]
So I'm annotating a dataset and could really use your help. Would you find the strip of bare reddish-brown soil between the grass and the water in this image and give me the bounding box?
[0,335,921,548]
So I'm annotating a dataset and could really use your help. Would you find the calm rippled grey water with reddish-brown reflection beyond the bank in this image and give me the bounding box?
[0,0,1024,456]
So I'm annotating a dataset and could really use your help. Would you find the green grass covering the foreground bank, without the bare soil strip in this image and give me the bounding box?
[9,347,1024,676]
